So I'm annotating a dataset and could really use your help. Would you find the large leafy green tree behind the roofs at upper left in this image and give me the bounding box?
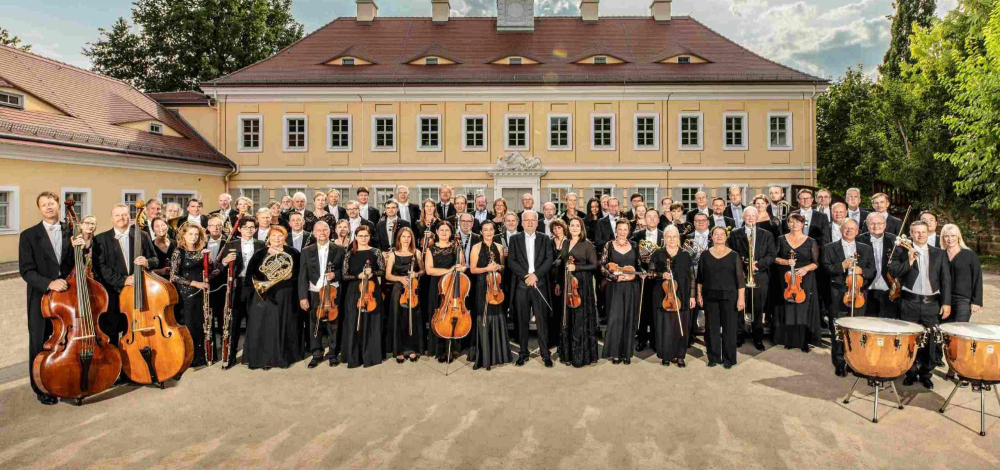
[83,0,303,91]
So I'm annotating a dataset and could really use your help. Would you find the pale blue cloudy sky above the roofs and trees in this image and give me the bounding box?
[7,0,956,77]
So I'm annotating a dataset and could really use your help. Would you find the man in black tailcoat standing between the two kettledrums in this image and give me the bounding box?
[889,220,951,389]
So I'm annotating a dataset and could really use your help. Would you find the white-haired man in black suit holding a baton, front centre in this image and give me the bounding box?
[507,210,553,367]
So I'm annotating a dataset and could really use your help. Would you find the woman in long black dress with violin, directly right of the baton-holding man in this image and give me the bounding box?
[555,217,599,367]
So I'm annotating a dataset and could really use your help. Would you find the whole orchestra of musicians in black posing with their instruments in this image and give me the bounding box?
[19,186,983,404]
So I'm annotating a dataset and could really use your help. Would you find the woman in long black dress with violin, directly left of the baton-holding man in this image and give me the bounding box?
[469,220,514,370]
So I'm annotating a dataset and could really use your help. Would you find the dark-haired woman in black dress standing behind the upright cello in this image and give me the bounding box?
[424,220,466,363]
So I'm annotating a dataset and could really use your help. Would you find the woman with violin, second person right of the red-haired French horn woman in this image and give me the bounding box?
[341,225,385,369]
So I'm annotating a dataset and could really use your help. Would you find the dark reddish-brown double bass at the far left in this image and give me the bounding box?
[31,198,122,405]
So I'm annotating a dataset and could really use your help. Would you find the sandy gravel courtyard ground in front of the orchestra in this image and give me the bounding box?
[0,276,1000,470]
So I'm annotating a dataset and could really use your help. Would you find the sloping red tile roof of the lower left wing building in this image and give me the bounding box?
[0,46,235,167]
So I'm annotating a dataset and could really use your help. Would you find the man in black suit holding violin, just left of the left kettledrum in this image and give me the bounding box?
[820,219,875,377]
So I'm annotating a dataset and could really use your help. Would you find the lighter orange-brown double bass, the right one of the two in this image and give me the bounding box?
[118,200,194,389]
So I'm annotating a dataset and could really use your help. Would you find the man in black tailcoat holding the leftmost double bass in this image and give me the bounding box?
[17,191,83,405]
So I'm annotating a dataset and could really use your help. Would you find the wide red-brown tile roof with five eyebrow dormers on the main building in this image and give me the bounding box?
[203,16,827,88]
